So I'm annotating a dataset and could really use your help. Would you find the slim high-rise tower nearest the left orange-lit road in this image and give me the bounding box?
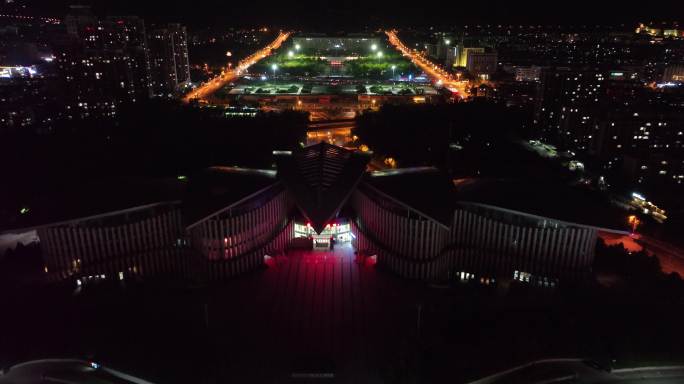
[149,24,190,96]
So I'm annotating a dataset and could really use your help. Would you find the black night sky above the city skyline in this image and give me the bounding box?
[20,0,684,30]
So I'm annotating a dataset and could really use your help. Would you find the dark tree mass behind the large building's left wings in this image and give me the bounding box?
[0,101,307,220]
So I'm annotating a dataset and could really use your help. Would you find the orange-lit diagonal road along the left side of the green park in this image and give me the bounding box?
[183,32,290,103]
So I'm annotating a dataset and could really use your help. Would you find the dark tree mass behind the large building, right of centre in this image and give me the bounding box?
[357,101,572,179]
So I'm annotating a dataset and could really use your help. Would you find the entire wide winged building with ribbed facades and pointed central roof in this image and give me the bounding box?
[4,143,624,286]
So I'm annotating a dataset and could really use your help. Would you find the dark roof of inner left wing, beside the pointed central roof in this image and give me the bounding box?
[183,167,277,226]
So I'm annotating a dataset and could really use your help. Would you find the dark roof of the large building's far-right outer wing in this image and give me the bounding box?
[454,178,625,231]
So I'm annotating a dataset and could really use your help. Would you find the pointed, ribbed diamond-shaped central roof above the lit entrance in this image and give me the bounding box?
[278,142,368,233]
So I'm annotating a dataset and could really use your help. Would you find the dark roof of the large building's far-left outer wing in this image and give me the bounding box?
[0,177,186,232]
